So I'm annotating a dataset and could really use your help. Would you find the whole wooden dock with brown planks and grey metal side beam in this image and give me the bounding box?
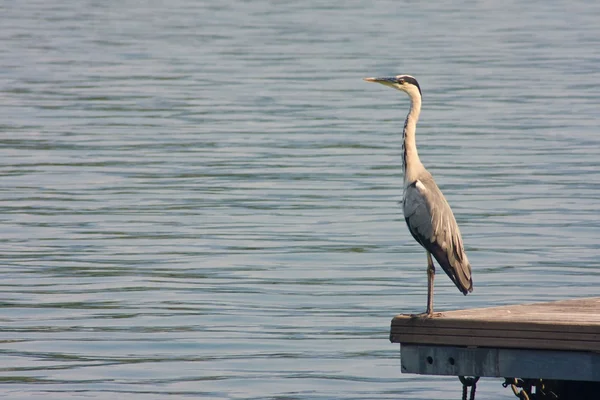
[390,297,600,399]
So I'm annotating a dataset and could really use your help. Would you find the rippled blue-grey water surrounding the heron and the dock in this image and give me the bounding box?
[0,0,600,400]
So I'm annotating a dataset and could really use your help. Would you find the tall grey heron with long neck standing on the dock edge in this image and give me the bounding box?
[365,75,473,317]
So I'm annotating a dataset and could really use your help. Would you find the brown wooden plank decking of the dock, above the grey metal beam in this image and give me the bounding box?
[390,297,600,352]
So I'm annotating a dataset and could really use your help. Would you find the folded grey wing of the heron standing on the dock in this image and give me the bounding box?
[403,177,473,294]
